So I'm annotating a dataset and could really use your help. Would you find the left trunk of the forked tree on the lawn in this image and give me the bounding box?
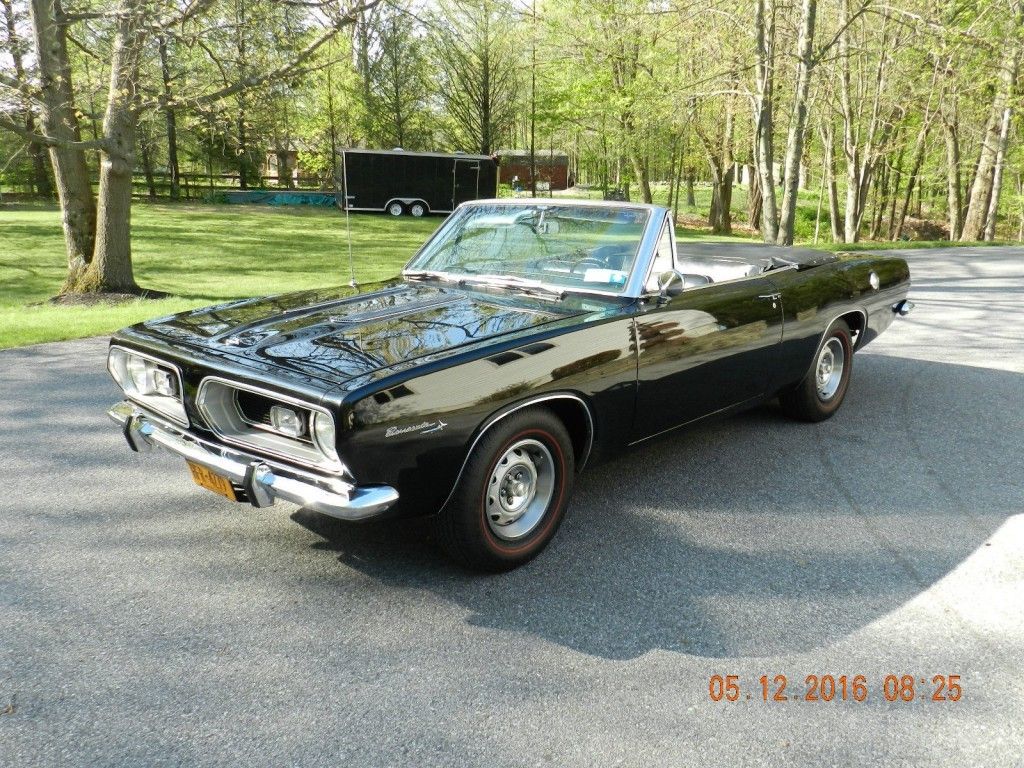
[29,0,96,291]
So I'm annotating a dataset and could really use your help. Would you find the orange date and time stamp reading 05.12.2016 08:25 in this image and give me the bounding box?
[708,674,964,703]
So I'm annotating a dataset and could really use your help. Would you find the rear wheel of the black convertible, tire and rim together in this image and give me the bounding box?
[778,321,853,422]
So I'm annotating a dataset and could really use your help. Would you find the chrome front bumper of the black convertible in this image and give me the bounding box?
[108,400,398,520]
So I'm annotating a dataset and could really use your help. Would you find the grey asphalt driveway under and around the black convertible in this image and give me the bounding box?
[0,248,1024,768]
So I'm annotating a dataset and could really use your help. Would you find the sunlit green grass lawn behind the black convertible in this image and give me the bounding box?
[0,201,1007,348]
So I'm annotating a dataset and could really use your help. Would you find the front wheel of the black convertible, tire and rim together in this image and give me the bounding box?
[434,408,575,571]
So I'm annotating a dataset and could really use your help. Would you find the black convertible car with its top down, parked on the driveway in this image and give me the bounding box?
[109,200,910,570]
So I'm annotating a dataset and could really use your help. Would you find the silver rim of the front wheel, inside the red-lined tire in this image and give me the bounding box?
[483,439,555,541]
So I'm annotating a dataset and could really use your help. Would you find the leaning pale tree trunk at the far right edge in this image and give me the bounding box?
[961,5,1024,241]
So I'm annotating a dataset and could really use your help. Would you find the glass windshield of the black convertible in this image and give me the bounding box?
[404,202,649,293]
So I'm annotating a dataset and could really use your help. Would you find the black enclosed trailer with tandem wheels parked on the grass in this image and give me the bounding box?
[340,150,498,216]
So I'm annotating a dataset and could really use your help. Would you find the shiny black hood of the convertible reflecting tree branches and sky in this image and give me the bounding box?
[135,282,582,384]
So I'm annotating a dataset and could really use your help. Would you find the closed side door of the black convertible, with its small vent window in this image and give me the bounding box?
[633,222,782,441]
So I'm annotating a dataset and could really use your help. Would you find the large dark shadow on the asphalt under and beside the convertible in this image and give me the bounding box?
[293,354,1024,658]
